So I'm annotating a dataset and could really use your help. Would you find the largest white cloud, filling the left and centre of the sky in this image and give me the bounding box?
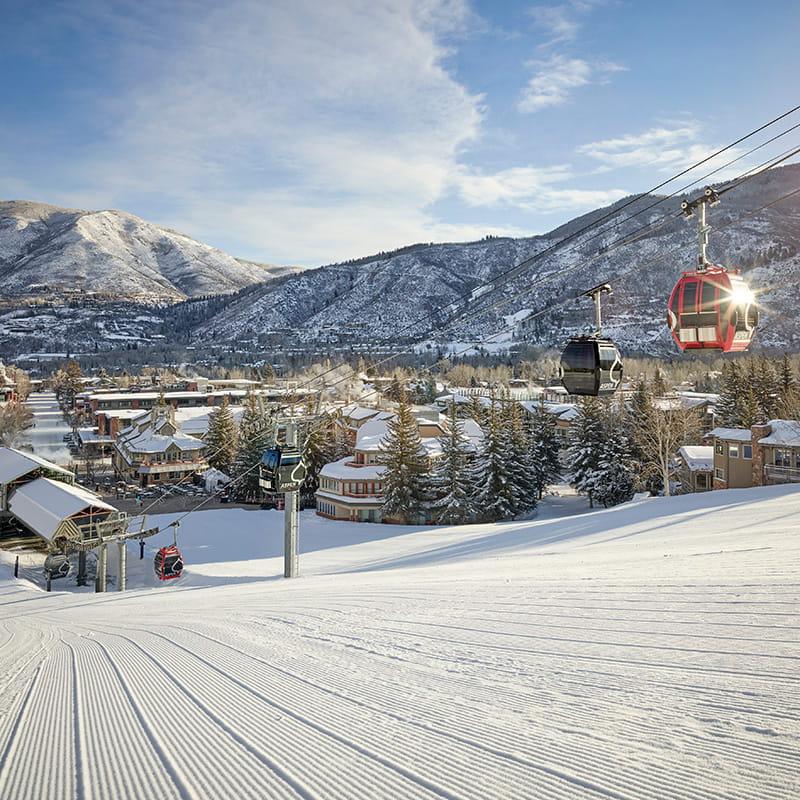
[31,0,484,260]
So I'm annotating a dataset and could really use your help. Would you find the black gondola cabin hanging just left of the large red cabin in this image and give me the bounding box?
[561,336,622,397]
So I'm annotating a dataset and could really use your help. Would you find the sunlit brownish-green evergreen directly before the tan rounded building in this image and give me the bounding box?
[378,392,428,524]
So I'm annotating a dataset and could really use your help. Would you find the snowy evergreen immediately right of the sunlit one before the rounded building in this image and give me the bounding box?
[430,401,477,525]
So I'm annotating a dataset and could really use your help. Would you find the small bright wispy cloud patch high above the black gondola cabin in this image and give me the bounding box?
[517,55,625,114]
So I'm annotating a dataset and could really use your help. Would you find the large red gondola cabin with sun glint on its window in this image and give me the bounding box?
[667,267,758,353]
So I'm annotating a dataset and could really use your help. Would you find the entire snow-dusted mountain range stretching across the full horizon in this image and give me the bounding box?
[0,165,800,355]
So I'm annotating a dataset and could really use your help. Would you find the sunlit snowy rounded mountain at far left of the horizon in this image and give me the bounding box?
[0,201,296,302]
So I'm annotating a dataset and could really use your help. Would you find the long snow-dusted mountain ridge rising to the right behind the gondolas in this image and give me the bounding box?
[197,165,800,353]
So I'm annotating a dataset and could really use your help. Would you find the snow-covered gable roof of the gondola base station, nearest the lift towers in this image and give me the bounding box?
[8,478,116,539]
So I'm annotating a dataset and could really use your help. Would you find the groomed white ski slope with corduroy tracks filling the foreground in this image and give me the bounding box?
[0,487,800,800]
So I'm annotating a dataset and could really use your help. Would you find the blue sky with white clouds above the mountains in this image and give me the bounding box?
[0,0,800,265]
